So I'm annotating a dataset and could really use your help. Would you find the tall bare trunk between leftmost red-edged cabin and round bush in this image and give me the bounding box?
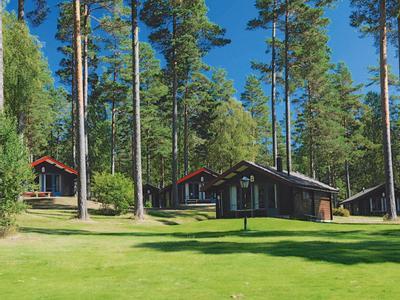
[74,0,88,220]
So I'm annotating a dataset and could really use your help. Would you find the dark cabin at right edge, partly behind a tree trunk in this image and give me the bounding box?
[339,183,400,216]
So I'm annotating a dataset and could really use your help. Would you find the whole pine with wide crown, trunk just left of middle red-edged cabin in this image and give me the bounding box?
[141,0,229,206]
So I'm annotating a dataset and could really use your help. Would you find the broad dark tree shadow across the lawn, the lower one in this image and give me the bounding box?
[135,240,400,265]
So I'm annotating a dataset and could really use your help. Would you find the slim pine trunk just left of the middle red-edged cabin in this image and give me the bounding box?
[172,14,179,208]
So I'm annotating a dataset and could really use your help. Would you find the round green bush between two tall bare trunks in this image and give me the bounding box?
[92,173,133,214]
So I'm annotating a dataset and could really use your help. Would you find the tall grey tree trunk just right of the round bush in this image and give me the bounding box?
[131,0,144,220]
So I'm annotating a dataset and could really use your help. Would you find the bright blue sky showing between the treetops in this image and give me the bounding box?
[7,0,397,102]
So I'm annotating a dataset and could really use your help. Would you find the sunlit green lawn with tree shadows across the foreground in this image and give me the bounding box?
[0,210,400,300]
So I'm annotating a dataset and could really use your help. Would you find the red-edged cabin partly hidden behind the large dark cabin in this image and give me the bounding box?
[160,168,218,207]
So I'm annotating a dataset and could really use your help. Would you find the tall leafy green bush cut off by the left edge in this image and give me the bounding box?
[0,112,34,235]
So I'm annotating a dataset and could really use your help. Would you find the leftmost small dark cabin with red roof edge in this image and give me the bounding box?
[31,156,78,197]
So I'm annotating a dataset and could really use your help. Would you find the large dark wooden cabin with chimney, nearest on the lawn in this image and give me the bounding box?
[205,160,338,221]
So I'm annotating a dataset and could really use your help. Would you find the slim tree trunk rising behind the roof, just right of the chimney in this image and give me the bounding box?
[285,0,292,175]
